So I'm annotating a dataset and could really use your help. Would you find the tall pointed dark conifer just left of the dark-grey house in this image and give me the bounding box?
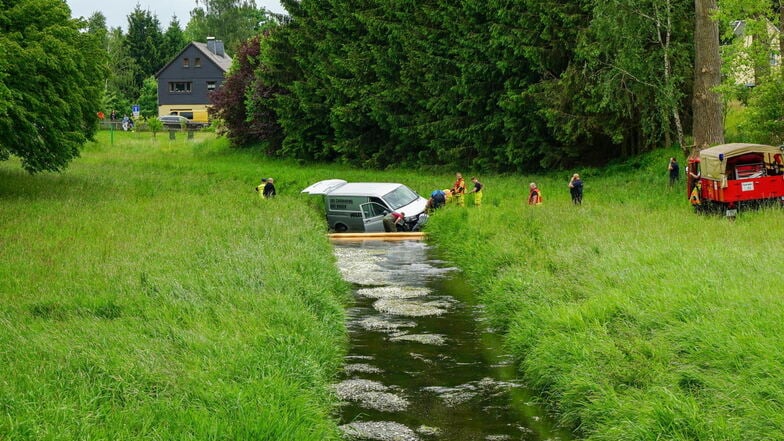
[124,4,168,88]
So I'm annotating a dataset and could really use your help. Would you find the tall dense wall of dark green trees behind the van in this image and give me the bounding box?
[261,0,694,170]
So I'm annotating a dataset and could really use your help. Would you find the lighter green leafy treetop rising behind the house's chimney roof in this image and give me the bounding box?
[185,0,274,54]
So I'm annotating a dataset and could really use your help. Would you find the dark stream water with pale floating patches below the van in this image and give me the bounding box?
[335,241,570,441]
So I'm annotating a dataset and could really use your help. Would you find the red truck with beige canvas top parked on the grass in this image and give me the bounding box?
[686,143,784,216]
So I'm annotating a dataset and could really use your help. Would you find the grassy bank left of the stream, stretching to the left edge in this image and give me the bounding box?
[0,133,347,441]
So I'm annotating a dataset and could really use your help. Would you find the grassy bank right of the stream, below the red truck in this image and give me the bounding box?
[429,151,784,440]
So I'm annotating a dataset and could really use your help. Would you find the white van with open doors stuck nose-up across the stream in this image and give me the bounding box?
[302,179,427,233]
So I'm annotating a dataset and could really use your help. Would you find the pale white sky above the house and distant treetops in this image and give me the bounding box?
[66,0,286,30]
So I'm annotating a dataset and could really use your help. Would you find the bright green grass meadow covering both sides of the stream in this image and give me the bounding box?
[0,132,784,441]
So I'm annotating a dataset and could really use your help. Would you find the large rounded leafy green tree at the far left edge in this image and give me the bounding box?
[0,0,106,173]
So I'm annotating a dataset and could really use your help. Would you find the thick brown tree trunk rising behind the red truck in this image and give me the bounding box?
[691,0,724,155]
